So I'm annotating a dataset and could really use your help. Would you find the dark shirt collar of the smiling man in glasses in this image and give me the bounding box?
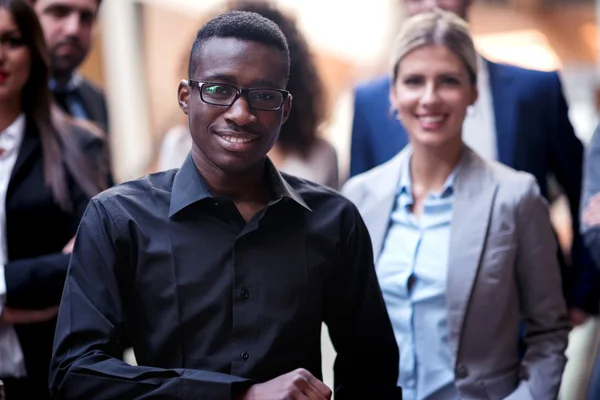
[169,154,312,217]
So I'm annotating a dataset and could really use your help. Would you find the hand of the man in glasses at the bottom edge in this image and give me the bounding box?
[239,369,332,400]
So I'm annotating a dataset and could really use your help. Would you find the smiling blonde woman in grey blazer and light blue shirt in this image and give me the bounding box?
[343,9,570,400]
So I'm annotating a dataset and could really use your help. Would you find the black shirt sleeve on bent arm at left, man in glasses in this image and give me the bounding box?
[50,200,251,400]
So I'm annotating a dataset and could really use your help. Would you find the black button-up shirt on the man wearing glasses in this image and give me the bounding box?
[51,157,401,400]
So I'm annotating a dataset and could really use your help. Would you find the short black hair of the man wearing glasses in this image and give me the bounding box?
[188,11,290,80]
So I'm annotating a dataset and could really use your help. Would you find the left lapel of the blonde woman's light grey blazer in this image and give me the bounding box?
[362,147,410,264]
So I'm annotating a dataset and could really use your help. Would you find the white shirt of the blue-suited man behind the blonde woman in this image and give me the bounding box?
[463,57,498,161]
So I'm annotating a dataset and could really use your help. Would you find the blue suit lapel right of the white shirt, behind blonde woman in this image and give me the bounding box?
[485,60,518,166]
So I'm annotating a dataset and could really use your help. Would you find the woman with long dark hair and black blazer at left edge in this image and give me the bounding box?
[0,0,108,400]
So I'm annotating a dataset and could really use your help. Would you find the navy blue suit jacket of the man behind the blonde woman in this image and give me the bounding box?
[350,61,600,314]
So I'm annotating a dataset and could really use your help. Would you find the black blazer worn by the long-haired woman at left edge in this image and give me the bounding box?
[5,120,104,399]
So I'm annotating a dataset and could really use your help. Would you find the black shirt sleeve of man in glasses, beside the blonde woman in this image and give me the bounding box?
[325,205,402,400]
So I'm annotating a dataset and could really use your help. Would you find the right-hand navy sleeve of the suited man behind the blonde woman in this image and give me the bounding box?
[548,73,600,314]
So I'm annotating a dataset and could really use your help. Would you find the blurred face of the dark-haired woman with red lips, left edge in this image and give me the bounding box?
[0,8,31,103]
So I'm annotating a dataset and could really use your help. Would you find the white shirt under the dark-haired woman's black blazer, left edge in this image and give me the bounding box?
[0,114,27,378]
